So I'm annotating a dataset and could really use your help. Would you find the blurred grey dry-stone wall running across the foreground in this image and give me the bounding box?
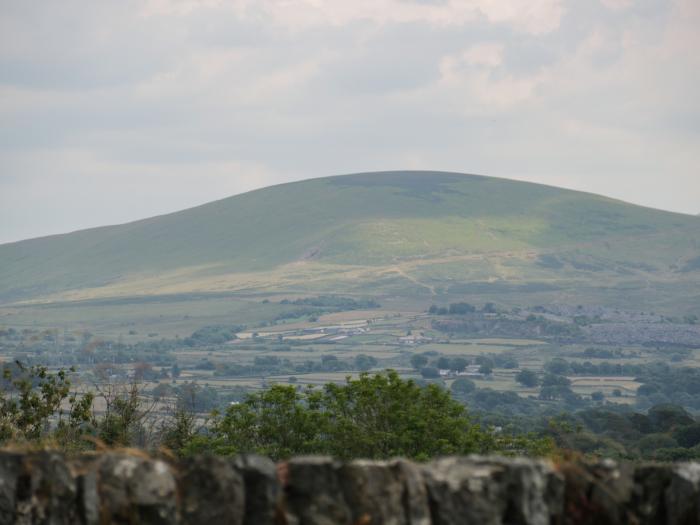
[0,451,700,525]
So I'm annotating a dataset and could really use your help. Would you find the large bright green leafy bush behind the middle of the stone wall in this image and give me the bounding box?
[202,371,546,460]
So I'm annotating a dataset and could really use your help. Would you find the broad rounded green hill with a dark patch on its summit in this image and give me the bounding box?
[0,171,700,312]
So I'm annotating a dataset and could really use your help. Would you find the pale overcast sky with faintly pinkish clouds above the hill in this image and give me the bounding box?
[0,0,700,243]
